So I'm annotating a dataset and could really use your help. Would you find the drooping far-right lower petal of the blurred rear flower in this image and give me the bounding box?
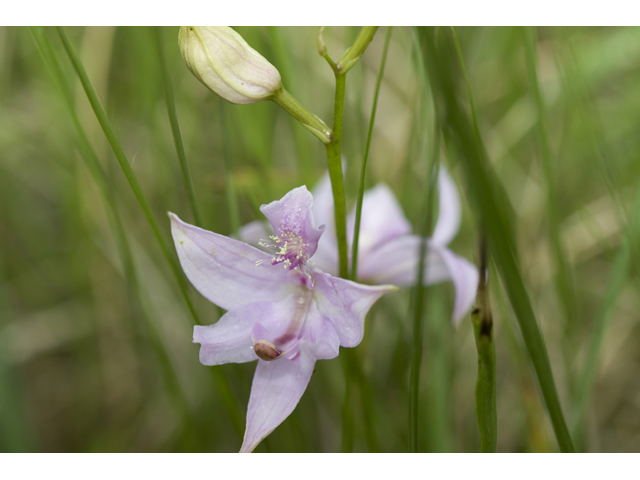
[432,246,479,325]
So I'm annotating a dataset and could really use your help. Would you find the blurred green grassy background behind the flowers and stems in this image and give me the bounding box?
[0,27,640,452]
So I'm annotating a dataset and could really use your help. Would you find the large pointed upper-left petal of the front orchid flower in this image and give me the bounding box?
[169,213,299,310]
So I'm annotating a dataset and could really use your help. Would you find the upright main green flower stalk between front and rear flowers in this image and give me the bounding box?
[326,73,349,278]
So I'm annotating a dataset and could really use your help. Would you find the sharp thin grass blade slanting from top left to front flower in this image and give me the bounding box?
[58,27,200,325]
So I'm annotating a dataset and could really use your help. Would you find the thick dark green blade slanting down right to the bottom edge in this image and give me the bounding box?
[419,28,574,452]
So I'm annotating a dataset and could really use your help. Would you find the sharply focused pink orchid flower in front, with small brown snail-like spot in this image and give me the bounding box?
[169,186,397,452]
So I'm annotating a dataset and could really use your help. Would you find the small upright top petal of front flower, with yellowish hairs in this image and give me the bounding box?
[260,185,325,257]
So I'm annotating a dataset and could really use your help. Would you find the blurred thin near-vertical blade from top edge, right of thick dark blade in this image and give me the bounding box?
[524,27,576,342]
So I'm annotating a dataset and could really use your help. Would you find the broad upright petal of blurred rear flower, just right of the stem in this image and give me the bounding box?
[347,183,411,257]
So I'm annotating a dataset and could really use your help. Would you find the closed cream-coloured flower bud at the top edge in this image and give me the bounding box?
[178,27,282,104]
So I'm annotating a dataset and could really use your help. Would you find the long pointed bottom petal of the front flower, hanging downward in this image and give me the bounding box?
[240,358,315,453]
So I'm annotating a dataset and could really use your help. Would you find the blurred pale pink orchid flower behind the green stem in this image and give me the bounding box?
[240,167,478,324]
